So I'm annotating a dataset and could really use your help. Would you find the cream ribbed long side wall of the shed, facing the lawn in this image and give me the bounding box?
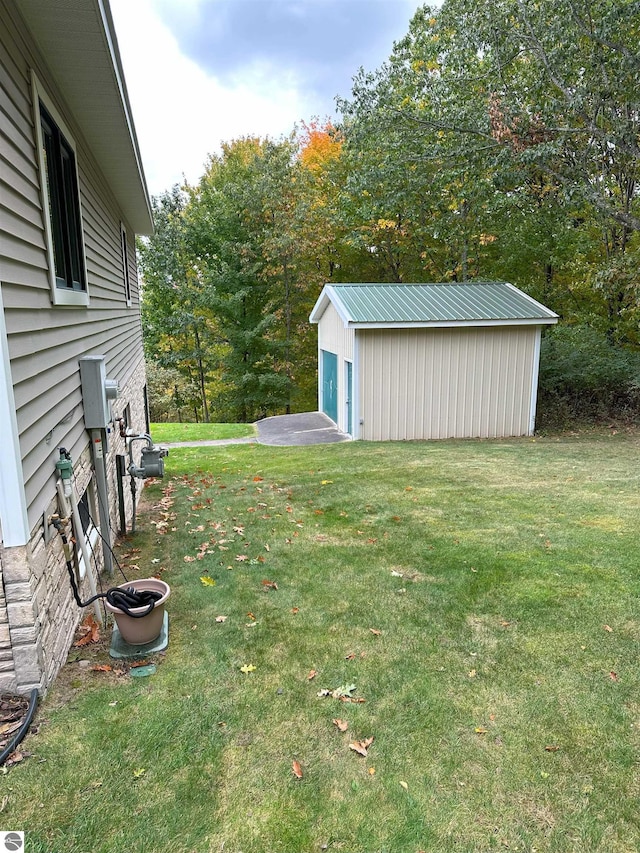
[358,327,536,441]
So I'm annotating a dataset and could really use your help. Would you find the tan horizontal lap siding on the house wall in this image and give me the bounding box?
[0,0,144,528]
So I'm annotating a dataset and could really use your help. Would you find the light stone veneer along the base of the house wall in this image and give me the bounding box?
[0,361,146,694]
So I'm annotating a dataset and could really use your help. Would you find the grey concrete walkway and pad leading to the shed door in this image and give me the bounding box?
[162,412,351,447]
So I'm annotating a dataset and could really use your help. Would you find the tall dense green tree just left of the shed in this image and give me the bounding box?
[187,138,288,422]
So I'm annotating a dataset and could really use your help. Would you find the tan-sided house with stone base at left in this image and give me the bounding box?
[0,0,153,693]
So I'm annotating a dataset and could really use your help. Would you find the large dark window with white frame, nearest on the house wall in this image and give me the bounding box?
[33,76,89,305]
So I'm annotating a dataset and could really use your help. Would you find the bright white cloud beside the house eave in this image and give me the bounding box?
[111,0,307,195]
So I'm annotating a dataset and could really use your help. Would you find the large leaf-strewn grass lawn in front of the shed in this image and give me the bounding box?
[5,435,640,853]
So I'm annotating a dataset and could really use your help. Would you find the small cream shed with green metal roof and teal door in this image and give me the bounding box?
[310,282,558,441]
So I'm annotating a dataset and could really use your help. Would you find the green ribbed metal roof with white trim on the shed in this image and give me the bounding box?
[310,282,558,328]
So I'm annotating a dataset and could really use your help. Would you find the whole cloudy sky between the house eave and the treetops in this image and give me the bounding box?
[110,0,422,195]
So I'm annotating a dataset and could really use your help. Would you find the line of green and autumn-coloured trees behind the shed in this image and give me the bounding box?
[139,0,640,421]
